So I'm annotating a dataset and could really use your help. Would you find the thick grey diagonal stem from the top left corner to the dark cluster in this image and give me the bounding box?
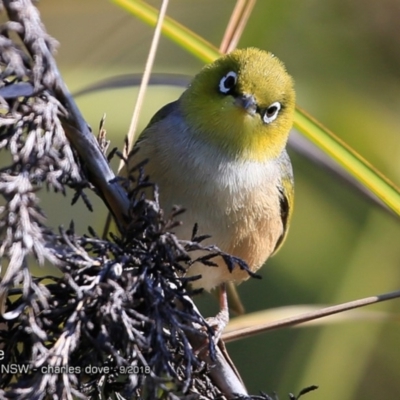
[3,0,129,227]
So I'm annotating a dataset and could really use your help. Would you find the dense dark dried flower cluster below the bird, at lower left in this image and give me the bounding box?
[0,179,225,399]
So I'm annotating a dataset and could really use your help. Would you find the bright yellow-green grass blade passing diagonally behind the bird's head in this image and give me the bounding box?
[111,0,400,216]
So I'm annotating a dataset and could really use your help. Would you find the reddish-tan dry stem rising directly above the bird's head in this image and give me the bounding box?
[219,0,256,54]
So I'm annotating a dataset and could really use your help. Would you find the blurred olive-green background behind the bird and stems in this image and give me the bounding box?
[33,0,400,400]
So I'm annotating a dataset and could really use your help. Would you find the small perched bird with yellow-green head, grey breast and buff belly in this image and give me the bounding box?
[133,48,295,322]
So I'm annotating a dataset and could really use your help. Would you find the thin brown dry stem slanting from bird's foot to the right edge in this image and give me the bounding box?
[222,290,400,343]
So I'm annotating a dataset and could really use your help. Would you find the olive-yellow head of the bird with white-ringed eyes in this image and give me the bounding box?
[179,48,295,161]
